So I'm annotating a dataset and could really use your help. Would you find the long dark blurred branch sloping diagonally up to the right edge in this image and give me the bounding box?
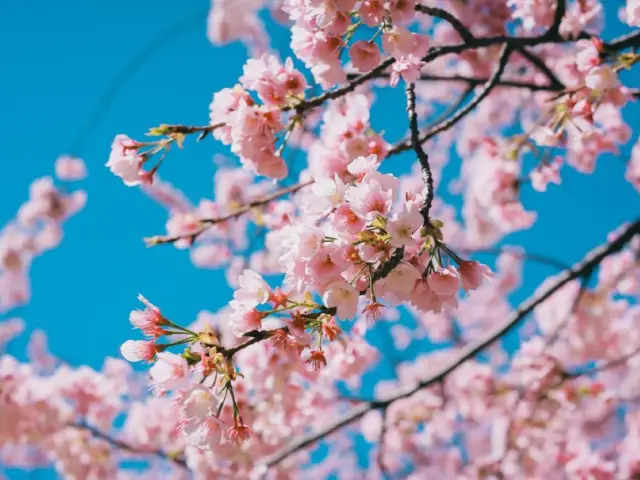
[262,219,640,467]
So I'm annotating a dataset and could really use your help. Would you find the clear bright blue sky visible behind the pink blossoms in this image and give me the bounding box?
[0,0,640,476]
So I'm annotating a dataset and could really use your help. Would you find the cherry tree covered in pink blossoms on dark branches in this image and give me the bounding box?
[0,0,640,480]
